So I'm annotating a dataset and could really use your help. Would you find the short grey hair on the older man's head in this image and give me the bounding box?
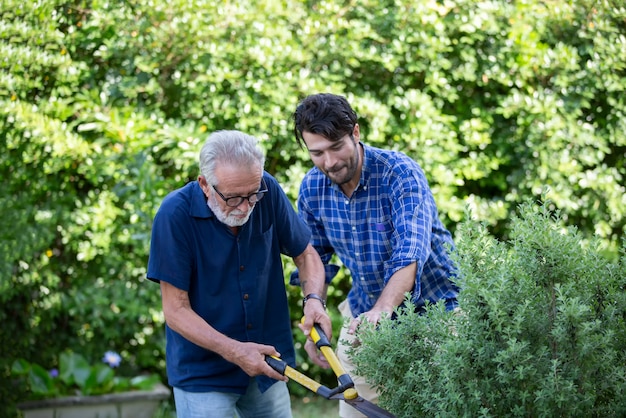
[199,130,265,184]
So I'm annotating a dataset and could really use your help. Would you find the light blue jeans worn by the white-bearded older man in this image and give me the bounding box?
[174,378,292,418]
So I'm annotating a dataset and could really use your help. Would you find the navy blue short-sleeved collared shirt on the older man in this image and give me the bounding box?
[147,172,311,394]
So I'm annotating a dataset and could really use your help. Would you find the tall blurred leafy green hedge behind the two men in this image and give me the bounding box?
[0,0,626,414]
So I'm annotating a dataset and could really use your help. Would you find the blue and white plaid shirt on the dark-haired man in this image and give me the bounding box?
[291,144,458,316]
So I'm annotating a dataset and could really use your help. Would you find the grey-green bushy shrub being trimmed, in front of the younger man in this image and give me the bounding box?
[352,202,626,417]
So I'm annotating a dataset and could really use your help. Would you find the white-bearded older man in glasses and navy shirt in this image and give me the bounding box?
[147,131,331,418]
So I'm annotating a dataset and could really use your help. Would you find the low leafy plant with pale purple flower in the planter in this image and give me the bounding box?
[12,351,160,399]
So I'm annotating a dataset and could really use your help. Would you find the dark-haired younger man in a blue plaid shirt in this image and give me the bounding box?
[292,93,458,418]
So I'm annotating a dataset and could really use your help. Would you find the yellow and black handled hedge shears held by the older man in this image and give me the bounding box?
[265,318,395,418]
